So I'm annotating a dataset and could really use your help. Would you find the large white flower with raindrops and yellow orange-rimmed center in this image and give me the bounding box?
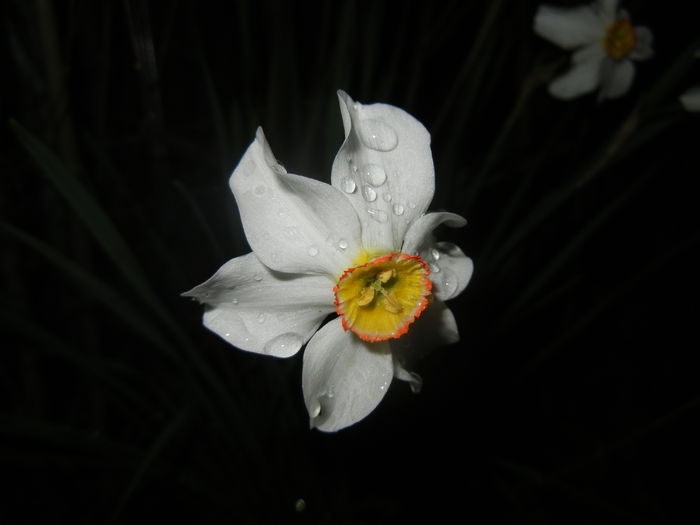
[185,91,473,432]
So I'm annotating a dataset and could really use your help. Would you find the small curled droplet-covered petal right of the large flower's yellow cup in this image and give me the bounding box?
[420,242,474,301]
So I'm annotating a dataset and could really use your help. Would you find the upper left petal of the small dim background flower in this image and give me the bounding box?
[534,5,605,49]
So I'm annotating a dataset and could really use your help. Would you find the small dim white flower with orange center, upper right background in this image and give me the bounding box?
[535,0,653,100]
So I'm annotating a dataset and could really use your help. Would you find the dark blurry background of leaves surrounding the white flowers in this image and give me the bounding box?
[0,0,700,524]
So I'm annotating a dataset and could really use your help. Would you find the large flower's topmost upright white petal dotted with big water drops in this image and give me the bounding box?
[331,91,435,252]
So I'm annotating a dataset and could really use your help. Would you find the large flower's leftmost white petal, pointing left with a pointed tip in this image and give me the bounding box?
[183,253,335,357]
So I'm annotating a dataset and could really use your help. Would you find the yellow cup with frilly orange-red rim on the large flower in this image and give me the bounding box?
[333,253,432,342]
